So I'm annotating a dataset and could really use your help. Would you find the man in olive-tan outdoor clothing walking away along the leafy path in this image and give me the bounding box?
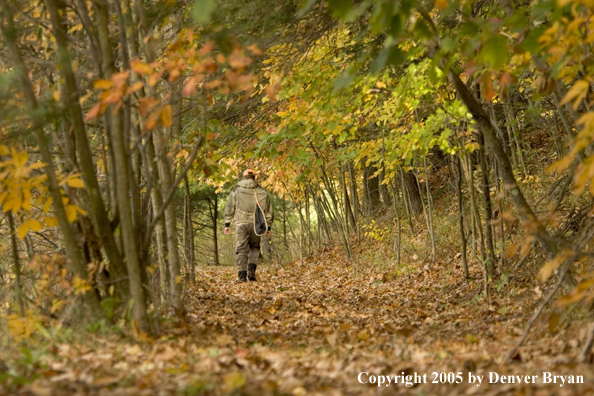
[225,169,274,282]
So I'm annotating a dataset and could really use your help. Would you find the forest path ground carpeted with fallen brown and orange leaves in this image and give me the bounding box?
[0,240,594,396]
